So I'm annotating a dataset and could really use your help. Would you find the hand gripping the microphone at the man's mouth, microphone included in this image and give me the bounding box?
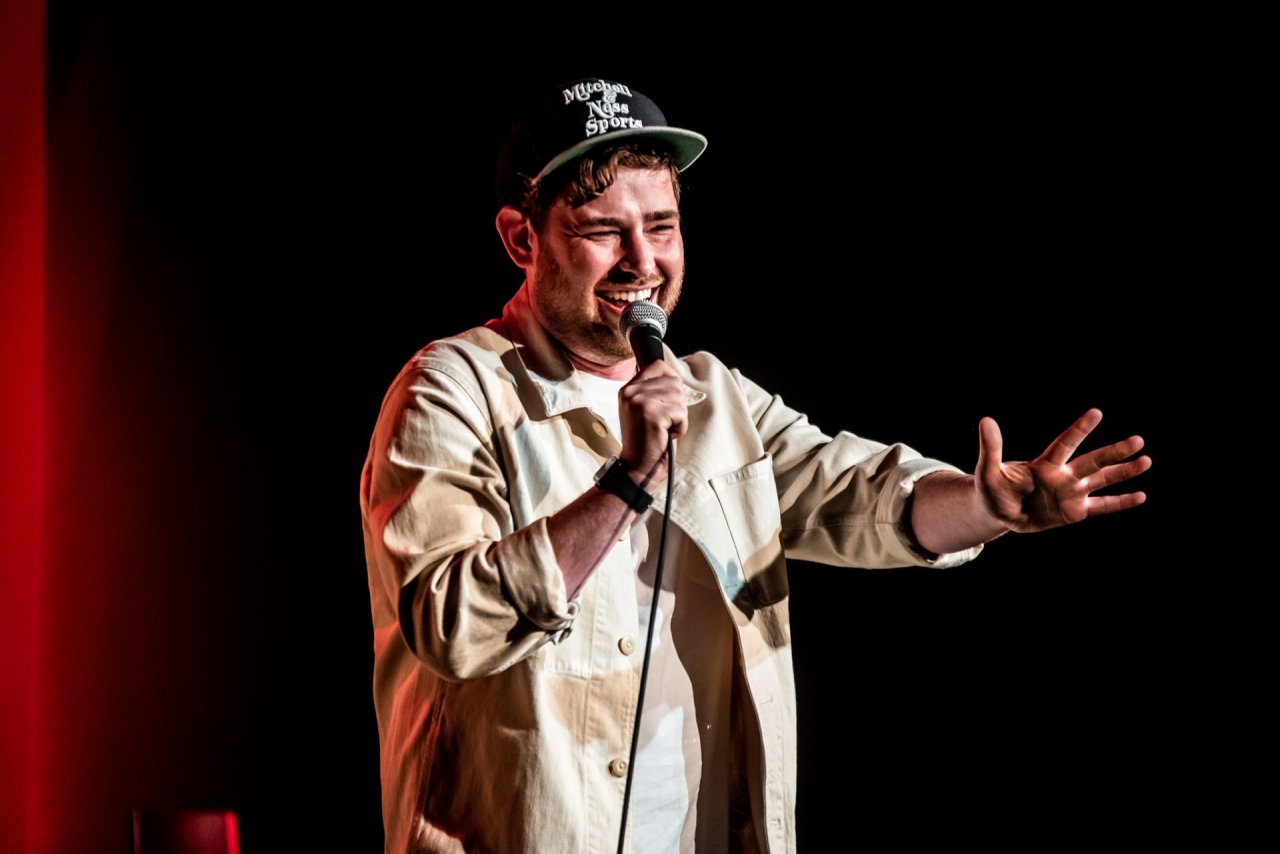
[618,300,689,492]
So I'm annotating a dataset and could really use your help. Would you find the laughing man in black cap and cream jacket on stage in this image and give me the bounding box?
[361,79,1149,853]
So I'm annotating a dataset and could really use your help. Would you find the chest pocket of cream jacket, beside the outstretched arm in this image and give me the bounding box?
[709,455,787,607]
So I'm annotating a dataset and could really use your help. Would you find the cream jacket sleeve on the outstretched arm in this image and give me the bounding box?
[735,371,982,568]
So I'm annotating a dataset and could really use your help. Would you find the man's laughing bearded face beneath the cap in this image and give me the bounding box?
[529,168,685,370]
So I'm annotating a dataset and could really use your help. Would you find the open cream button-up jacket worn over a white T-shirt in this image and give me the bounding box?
[360,288,978,854]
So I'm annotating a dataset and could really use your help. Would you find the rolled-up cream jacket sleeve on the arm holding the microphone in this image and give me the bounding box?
[361,359,577,680]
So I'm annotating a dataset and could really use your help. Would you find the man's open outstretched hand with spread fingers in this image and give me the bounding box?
[974,408,1151,533]
